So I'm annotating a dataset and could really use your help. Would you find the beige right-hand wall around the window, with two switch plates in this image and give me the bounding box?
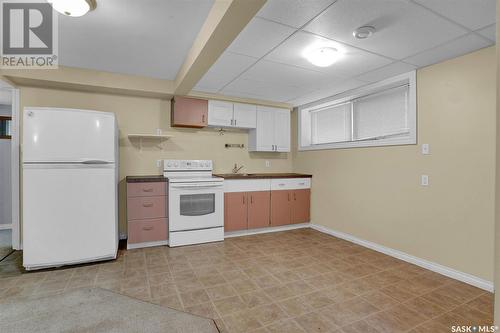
[292,47,496,281]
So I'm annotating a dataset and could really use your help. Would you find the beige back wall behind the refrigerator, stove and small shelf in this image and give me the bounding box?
[20,87,292,232]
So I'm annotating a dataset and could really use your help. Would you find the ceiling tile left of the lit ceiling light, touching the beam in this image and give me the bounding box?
[228,17,295,58]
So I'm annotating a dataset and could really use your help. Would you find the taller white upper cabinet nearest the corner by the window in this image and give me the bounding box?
[248,106,290,152]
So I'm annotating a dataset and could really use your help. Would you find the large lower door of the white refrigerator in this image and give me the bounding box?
[23,164,118,269]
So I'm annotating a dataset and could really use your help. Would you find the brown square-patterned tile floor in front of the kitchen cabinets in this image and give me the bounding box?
[0,229,493,333]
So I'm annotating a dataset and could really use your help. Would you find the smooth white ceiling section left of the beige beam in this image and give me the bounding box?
[58,0,214,80]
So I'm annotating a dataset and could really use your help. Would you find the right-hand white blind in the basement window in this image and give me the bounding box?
[353,85,409,140]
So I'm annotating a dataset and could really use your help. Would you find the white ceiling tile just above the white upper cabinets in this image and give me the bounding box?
[221,78,311,102]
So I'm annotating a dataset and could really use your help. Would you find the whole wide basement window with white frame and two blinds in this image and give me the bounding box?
[298,72,417,150]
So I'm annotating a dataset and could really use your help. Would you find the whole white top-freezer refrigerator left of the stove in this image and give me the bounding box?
[21,107,118,270]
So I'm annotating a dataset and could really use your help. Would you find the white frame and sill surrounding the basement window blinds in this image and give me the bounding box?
[297,71,417,151]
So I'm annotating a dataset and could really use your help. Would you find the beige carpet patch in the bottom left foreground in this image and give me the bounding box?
[0,288,218,333]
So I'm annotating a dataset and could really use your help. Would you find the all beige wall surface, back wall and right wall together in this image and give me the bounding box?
[16,47,496,281]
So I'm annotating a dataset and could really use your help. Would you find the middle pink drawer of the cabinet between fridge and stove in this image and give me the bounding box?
[127,196,167,220]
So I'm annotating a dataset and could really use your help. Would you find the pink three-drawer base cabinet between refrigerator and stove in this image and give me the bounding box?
[127,176,168,249]
